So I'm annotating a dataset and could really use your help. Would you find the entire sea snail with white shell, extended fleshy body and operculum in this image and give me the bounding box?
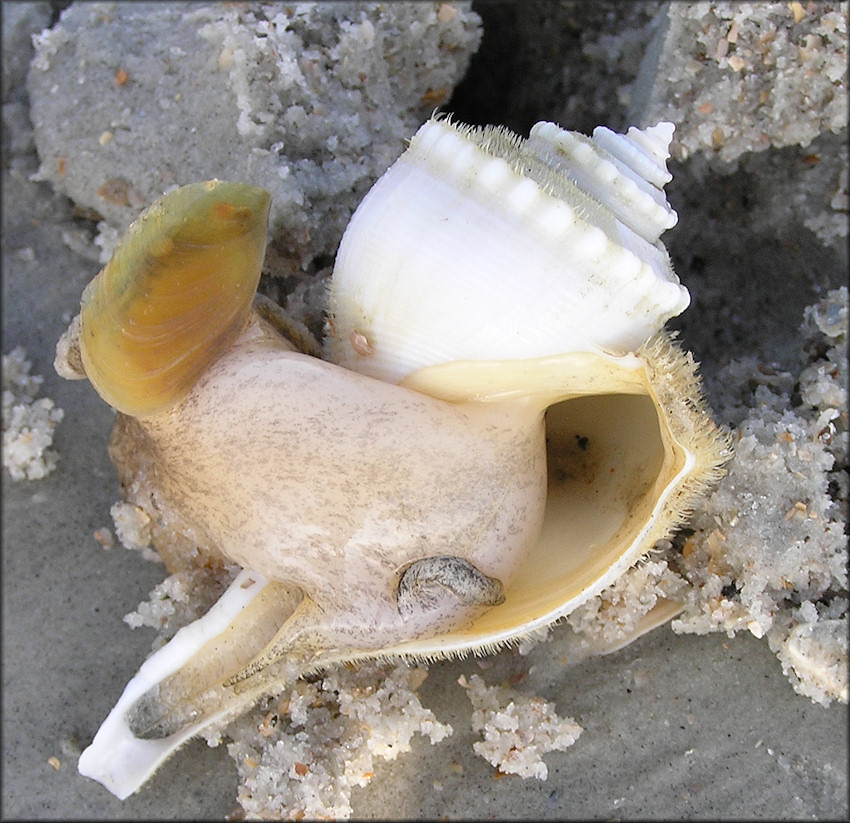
[57,119,729,798]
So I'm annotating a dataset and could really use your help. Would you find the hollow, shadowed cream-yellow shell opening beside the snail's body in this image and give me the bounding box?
[494,394,672,630]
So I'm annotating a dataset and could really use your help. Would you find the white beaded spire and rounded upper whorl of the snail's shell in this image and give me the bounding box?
[330,120,690,382]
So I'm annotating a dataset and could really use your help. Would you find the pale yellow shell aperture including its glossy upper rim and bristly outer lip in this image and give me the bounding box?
[372,334,728,657]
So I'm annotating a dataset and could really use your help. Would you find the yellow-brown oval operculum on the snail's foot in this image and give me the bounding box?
[80,180,271,417]
